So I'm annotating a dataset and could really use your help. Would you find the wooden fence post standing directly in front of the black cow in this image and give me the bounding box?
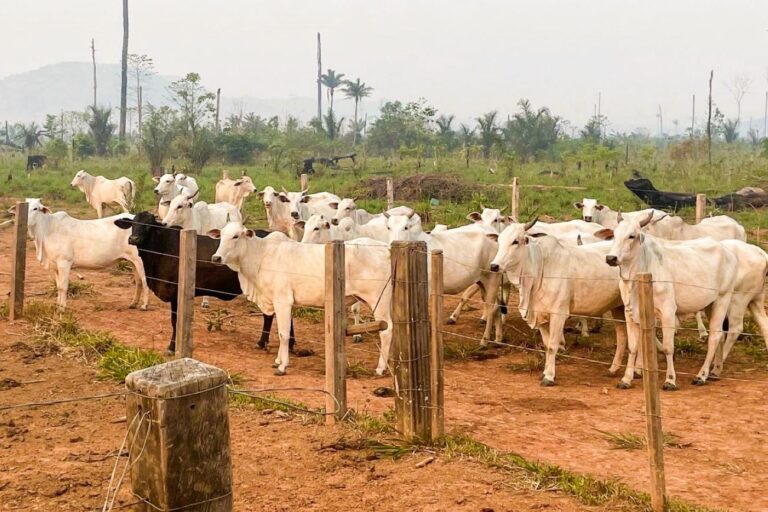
[176,229,197,358]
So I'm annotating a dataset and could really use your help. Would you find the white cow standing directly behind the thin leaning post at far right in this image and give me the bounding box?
[597,212,738,390]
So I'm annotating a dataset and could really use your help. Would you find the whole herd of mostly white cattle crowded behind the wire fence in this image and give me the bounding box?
[10,171,768,389]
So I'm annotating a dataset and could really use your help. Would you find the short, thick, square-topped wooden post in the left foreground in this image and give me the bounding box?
[125,358,232,512]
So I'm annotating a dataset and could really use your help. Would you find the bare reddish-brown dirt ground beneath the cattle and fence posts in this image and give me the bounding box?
[0,221,768,511]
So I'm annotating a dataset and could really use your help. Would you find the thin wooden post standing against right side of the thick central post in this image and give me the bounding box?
[429,249,445,441]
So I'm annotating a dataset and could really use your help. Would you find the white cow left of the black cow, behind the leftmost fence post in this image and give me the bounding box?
[12,199,149,311]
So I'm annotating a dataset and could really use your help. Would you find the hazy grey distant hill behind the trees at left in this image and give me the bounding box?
[0,62,379,123]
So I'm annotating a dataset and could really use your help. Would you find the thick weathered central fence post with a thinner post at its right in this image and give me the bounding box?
[390,242,433,440]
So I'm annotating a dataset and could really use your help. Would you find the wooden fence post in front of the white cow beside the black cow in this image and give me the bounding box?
[325,240,347,425]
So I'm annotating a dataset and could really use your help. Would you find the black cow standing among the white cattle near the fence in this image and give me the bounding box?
[115,212,296,353]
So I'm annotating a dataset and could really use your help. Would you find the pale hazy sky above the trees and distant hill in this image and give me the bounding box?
[0,0,768,133]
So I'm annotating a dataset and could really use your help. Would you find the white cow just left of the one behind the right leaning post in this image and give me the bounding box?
[491,219,627,386]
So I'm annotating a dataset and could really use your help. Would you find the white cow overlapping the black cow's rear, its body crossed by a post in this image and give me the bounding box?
[208,222,392,375]
